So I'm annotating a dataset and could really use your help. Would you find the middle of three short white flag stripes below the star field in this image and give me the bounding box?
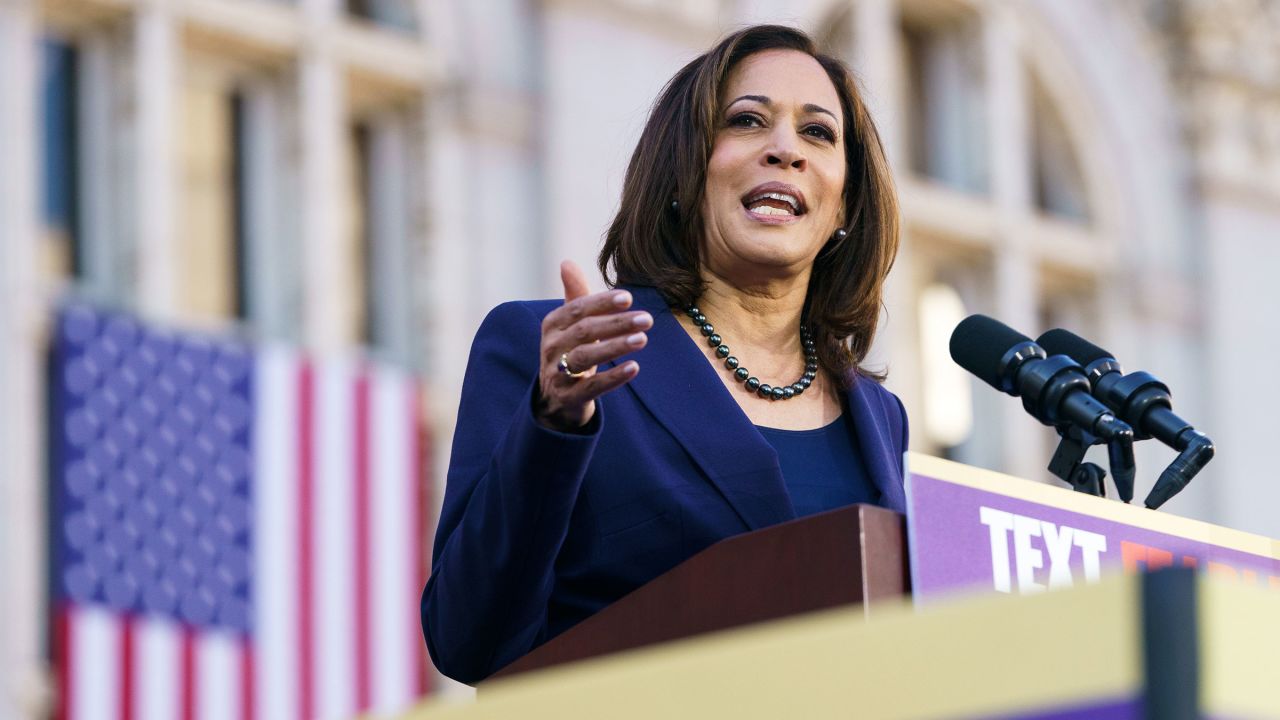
[133,618,182,720]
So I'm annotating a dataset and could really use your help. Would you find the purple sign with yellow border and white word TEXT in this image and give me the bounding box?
[906,455,1280,601]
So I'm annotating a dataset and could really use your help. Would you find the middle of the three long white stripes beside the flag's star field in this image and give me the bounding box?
[312,360,356,719]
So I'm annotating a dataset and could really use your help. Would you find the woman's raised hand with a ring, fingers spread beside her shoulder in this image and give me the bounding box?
[535,260,653,432]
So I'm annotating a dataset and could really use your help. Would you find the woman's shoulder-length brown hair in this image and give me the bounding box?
[598,26,899,384]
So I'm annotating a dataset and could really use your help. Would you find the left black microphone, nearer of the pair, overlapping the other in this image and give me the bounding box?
[951,315,1137,502]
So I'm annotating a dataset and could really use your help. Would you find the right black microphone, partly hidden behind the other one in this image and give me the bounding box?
[1038,328,1213,510]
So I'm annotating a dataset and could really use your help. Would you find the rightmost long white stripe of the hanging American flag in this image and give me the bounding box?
[370,370,416,712]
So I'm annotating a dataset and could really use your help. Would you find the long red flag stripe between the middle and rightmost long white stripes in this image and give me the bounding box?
[352,368,374,712]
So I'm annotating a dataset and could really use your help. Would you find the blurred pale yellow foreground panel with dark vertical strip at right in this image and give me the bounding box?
[408,569,1280,720]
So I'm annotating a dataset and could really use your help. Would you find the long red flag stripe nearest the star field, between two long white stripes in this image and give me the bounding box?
[297,360,316,720]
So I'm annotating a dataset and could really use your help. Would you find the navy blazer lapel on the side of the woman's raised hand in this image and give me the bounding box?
[616,287,795,530]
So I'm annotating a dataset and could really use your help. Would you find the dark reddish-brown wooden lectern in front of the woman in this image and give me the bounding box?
[490,505,910,679]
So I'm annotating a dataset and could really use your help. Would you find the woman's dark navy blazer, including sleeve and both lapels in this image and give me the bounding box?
[421,287,908,683]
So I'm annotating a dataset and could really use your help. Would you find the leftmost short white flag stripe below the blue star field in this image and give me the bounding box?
[69,606,123,720]
